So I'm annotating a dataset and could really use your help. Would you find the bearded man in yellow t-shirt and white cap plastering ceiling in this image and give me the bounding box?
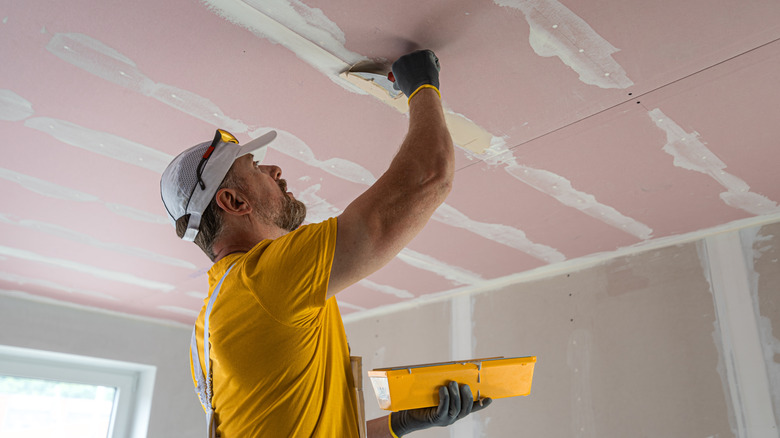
[161,50,490,438]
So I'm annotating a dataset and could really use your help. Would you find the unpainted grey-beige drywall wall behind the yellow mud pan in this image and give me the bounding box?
[346,224,780,438]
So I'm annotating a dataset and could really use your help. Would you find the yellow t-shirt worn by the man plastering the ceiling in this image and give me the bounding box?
[190,218,358,438]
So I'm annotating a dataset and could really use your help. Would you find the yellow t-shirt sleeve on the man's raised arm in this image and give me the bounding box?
[243,218,337,327]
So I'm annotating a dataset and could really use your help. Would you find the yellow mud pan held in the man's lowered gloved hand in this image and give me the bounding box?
[368,356,536,412]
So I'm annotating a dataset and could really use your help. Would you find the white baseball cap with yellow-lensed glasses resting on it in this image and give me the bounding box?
[160,129,276,242]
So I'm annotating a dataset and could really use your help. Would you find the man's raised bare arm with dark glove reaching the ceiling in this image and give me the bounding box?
[328,50,455,297]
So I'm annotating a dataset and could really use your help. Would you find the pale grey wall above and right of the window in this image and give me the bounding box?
[0,296,205,438]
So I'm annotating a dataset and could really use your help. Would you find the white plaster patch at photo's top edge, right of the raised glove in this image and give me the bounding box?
[493,0,634,88]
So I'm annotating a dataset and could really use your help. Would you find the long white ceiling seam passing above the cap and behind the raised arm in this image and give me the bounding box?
[44,34,563,261]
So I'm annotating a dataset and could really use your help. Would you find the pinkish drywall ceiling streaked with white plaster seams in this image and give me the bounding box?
[0,0,780,323]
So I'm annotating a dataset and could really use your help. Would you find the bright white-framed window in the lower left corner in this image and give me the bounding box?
[0,346,155,438]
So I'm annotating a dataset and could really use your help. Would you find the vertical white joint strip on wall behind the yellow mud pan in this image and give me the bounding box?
[450,295,477,438]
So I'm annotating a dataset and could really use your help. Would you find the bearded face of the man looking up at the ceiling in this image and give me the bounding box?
[234,154,306,231]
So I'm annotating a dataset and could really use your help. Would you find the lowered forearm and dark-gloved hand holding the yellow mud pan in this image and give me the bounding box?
[390,382,493,438]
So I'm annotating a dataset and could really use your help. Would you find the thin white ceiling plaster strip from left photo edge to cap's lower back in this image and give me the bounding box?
[0,167,171,225]
